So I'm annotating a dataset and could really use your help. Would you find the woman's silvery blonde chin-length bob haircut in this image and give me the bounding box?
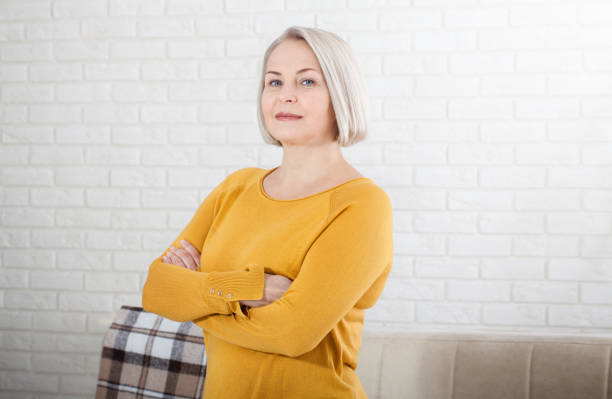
[257,26,368,147]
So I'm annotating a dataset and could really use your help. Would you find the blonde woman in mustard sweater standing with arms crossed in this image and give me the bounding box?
[142,27,393,399]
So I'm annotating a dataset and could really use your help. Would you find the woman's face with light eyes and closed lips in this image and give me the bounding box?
[261,39,336,146]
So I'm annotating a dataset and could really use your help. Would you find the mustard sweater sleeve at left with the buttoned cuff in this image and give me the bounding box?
[142,173,264,322]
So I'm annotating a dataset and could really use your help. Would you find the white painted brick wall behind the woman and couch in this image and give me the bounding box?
[0,0,612,398]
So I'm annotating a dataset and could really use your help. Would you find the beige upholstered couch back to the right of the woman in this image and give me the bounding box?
[356,331,612,399]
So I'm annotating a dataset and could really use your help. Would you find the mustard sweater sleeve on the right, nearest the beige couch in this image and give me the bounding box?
[194,190,393,357]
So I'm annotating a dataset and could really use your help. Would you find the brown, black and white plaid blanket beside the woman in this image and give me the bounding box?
[96,306,206,399]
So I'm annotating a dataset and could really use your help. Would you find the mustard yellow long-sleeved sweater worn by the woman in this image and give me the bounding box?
[142,167,393,399]
